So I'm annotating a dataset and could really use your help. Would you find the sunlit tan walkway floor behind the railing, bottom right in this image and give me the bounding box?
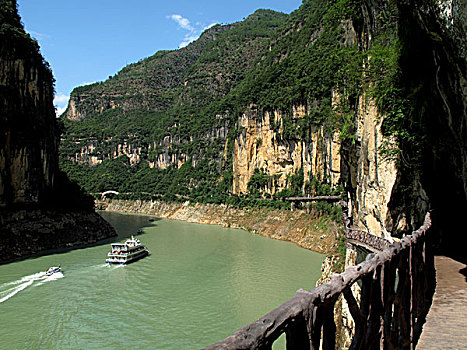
[417,256,467,350]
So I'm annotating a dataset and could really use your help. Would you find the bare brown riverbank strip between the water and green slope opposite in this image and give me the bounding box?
[96,199,340,254]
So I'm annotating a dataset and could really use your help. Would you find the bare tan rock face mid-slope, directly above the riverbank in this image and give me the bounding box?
[232,106,340,195]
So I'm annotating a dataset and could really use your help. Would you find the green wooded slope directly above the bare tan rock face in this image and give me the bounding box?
[228,0,362,129]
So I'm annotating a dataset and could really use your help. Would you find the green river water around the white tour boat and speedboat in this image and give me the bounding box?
[0,213,324,349]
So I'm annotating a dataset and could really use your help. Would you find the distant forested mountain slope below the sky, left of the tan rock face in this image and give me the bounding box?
[61,10,287,202]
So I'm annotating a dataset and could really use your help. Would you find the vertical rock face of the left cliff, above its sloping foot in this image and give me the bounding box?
[0,25,58,207]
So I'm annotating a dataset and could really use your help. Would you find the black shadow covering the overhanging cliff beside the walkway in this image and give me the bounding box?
[389,1,467,263]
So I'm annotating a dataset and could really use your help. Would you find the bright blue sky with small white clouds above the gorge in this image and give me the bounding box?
[18,0,302,113]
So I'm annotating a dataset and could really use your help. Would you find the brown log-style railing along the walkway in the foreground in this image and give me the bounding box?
[206,214,435,350]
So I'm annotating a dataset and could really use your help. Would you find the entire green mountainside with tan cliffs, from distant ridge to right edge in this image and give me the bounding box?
[61,0,467,258]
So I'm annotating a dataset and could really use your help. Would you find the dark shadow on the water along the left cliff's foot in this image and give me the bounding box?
[0,211,161,265]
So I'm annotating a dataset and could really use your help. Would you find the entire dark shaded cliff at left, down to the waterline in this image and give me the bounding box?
[0,0,115,261]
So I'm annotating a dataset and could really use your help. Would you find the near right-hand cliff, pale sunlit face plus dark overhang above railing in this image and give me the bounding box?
[342,1,467,249]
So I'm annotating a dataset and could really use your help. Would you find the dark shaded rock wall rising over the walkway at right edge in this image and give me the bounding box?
[390,0,467,257]
